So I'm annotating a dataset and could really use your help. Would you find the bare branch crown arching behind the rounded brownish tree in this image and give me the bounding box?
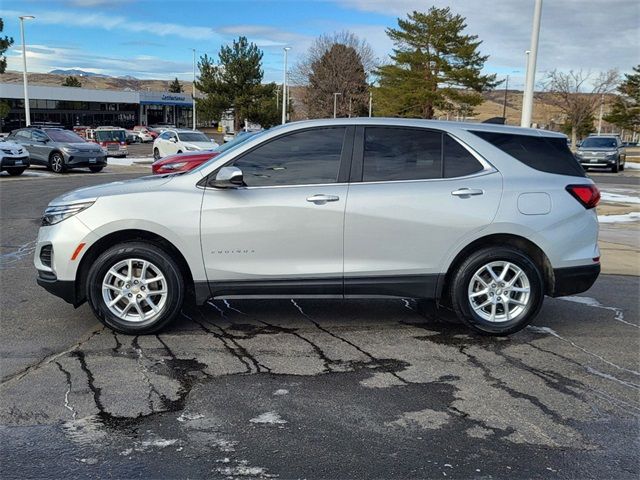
[291,31,378,85]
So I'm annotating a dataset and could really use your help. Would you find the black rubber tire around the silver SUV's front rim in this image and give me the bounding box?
[86,242,185,335]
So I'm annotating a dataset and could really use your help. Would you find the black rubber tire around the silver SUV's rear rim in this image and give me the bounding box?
[450,246,544,335]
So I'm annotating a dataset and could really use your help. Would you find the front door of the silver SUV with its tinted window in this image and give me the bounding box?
[201,127,352,296]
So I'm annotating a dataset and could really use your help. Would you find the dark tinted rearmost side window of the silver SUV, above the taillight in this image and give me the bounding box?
[471,131,586,177]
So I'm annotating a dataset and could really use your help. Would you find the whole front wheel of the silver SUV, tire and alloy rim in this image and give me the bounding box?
[86,242,184,335]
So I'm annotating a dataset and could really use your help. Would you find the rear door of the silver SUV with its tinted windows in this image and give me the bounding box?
[344,126,502,297]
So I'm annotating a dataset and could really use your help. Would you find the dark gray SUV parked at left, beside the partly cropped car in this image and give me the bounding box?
[8,127,107,173]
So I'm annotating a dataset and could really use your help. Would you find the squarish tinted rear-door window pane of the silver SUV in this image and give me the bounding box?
[362,127,442,182]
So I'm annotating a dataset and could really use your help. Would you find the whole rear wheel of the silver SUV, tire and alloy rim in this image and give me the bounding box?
[450,247,544,335]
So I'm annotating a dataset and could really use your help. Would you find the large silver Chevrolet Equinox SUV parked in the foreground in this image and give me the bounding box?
[35,118,600,334]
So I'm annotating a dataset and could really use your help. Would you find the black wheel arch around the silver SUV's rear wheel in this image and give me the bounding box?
[437,233,555,302]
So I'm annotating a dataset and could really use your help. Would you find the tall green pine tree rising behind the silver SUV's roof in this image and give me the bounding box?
[376,7,498,118]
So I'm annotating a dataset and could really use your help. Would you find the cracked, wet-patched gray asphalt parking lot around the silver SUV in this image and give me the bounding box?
[0,165,640,479]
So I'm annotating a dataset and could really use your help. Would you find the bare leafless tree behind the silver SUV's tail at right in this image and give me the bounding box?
[544,70,620,145]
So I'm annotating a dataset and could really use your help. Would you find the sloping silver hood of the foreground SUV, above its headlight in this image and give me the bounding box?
[49,175,173,205]
